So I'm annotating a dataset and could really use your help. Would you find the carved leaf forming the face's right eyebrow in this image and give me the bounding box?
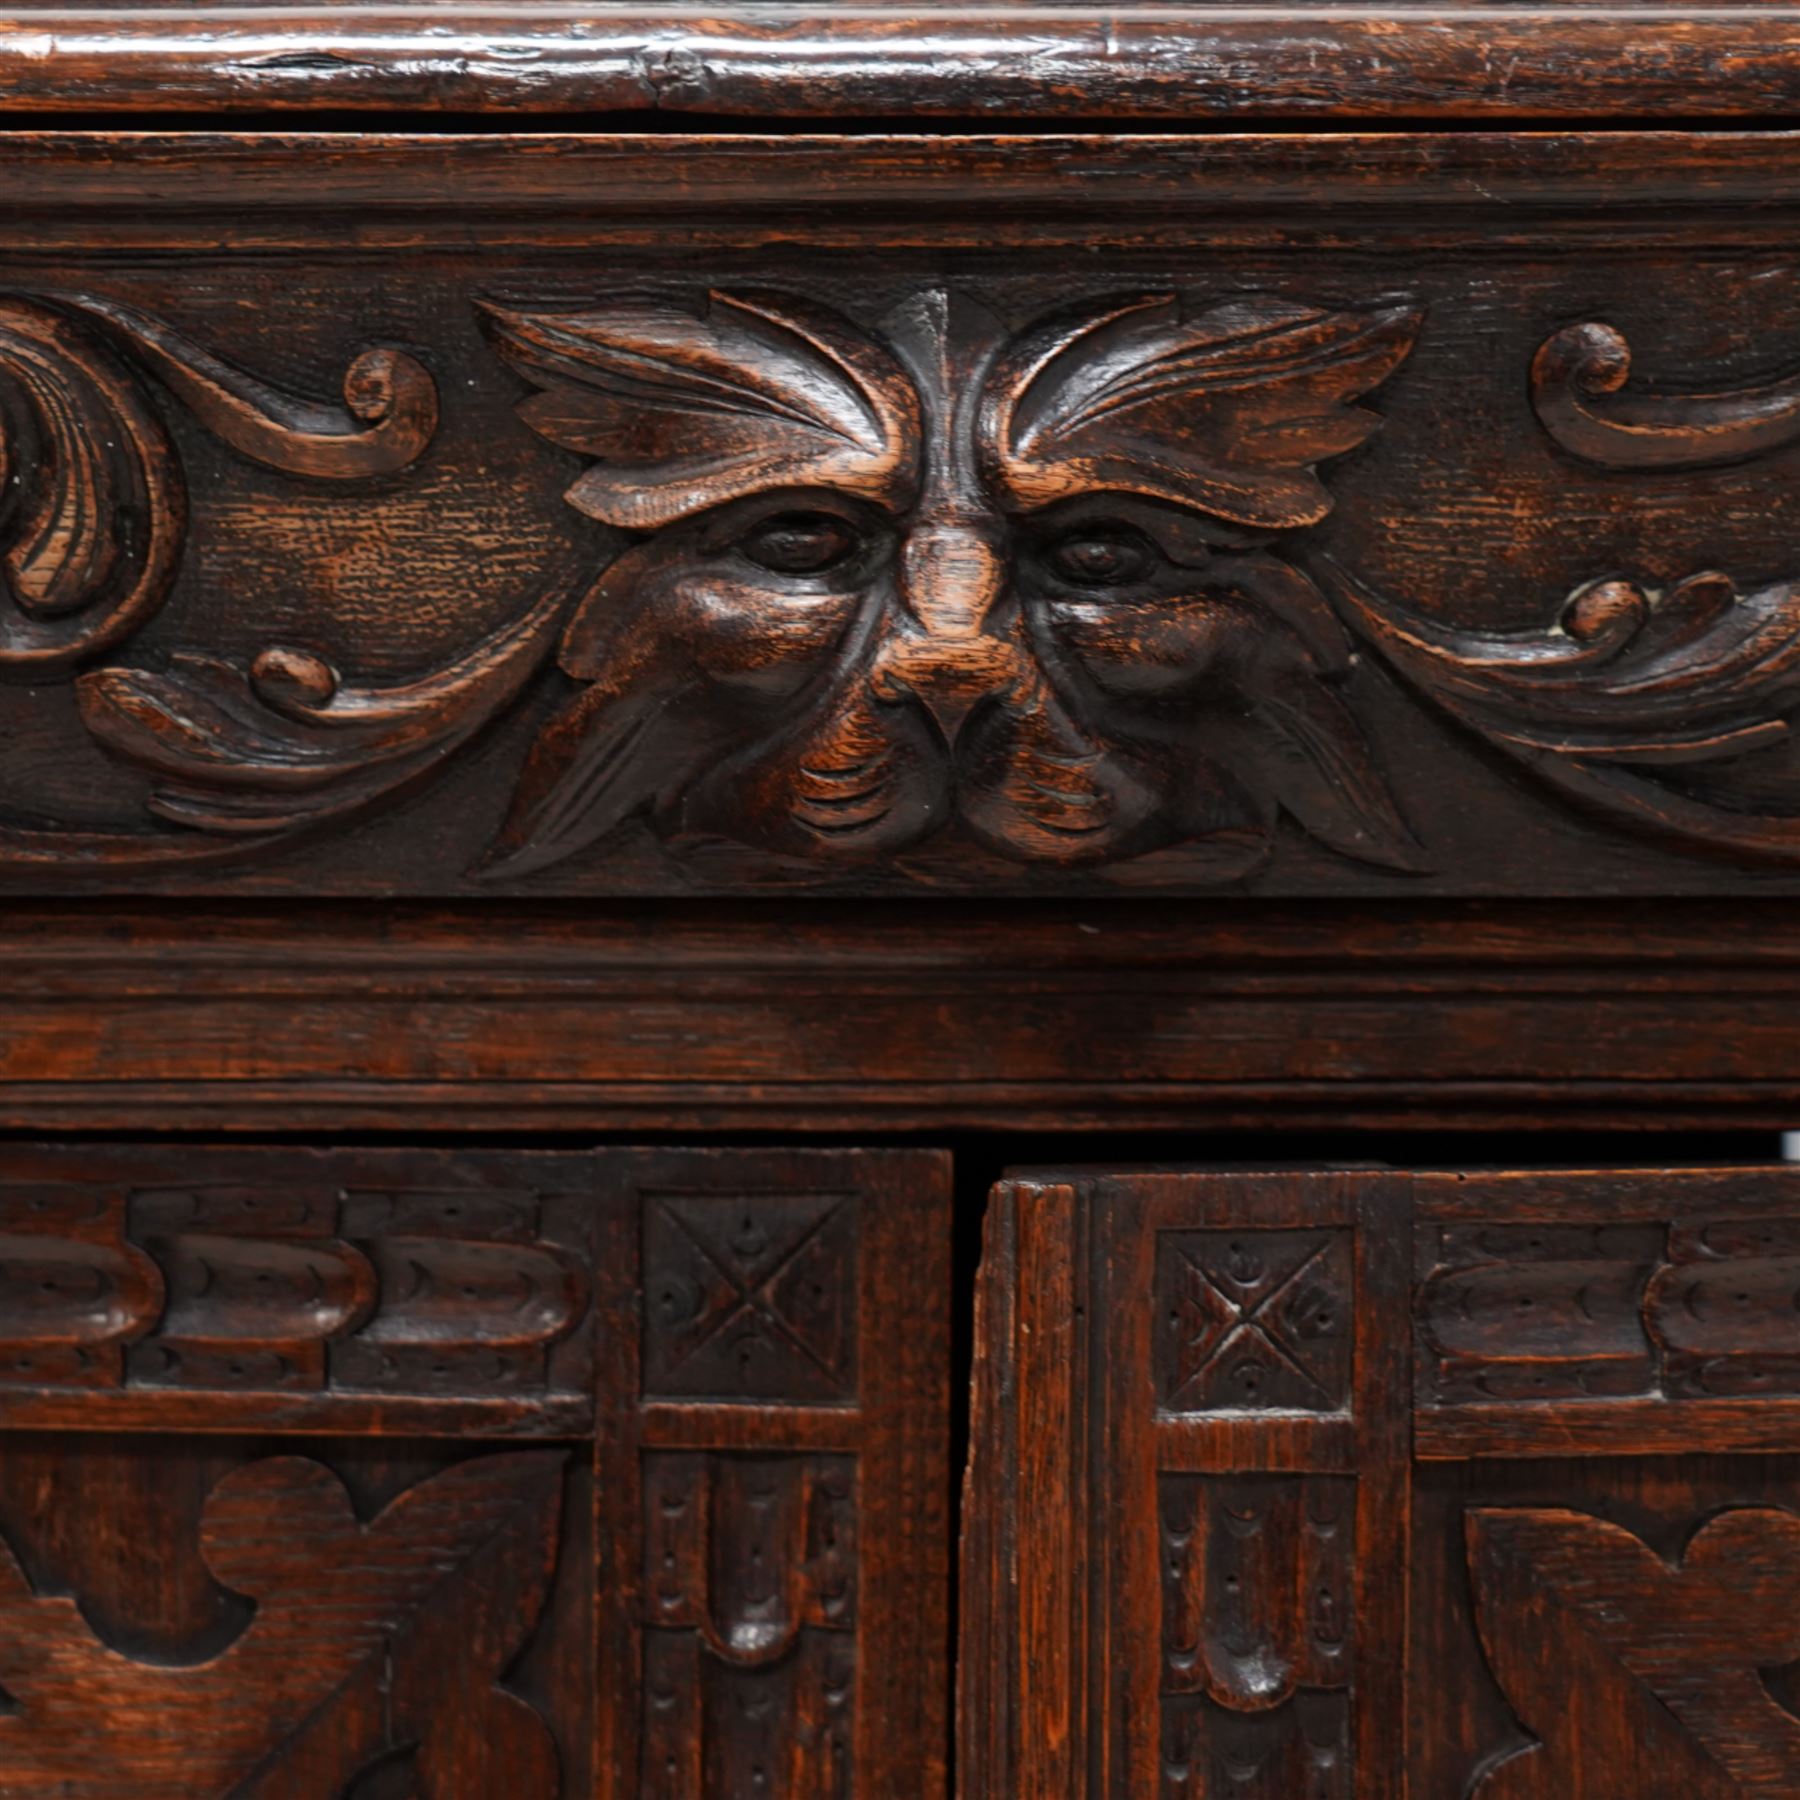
[983,295,1424,531]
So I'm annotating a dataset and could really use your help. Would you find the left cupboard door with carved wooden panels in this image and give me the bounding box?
[0,1148,949,1800]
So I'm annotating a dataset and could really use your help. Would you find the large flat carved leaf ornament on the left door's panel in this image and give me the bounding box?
[0,1451,565,1800]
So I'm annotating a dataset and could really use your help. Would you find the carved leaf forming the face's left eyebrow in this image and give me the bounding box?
[484,292,920,531]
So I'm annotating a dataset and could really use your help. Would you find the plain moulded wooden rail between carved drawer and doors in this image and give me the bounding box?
[10,902,1800,1134]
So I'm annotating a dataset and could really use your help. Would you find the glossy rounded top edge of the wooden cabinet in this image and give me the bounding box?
[0,0,1800,128]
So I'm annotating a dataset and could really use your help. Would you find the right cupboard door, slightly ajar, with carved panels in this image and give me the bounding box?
[961,1168,1800,1800]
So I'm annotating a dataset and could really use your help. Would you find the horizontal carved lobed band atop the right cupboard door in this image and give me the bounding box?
[1418,1217,1800,1406]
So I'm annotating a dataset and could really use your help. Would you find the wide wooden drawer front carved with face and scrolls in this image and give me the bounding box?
[10,133,1800,898]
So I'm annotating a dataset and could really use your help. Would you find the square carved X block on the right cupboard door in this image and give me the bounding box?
[1156,1229,1354,1413]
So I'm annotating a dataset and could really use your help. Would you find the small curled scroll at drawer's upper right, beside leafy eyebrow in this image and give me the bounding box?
[1532,320,1800,470]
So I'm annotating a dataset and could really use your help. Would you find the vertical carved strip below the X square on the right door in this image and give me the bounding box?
[1157,1474,1355,1800]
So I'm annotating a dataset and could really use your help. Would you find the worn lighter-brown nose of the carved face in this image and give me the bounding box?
[875,518,1021,743]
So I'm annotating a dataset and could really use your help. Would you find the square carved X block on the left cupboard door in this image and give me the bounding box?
[643,1192,859,1406]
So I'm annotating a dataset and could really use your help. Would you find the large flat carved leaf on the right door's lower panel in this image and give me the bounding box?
[1467,1508,1800,1800]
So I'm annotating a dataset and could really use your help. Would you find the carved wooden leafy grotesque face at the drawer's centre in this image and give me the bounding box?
[490,290,1418,875]
